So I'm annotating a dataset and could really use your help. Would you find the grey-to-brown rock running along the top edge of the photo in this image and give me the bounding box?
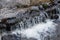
[0,0,50,8]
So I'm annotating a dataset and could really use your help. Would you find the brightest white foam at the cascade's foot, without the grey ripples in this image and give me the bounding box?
[12,20,56,40]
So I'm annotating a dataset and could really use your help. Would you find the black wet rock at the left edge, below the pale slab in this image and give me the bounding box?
[0,17,16,31]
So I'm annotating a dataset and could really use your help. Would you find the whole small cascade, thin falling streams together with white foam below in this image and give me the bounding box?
[12,11,57,40]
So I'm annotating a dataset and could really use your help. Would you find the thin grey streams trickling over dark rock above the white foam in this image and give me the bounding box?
[10,11,49,29]
